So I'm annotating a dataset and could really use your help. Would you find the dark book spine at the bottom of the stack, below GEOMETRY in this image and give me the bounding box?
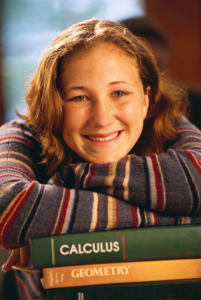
[48,280,201,300]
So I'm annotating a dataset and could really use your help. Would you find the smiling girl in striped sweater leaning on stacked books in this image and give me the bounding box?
[0,19,201,299]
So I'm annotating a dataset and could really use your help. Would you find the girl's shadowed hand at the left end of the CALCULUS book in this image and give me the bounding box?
[2,244,30,271]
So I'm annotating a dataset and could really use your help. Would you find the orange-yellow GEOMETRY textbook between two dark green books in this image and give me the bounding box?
[42,259,201,289]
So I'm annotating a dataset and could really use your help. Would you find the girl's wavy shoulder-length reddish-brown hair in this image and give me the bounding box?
[23,19,189,175]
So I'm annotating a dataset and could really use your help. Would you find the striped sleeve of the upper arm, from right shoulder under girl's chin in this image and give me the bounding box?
[58,119,201,215]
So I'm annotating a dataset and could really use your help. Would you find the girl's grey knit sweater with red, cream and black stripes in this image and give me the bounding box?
[0,120,201,299]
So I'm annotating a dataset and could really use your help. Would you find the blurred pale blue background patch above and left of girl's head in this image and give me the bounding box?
[0,0,144,121]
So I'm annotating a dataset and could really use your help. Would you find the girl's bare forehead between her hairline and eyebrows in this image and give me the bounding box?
[60,43,140,88]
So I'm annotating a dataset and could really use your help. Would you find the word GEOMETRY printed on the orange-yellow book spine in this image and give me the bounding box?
[71,265,130,278]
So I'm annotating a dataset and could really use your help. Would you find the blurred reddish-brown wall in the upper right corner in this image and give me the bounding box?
[145,0,201,90]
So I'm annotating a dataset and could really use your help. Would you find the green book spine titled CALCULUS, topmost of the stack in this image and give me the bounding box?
[31,225,201,268]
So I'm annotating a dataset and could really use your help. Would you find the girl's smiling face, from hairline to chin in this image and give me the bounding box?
[60,43,150,163]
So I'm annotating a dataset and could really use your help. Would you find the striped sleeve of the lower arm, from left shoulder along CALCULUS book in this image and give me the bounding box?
[0,122,201,249]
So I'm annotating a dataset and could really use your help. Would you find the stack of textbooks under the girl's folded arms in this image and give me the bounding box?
[31,225,201,300]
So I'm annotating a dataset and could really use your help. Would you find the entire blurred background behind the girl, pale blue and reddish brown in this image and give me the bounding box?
[0,0,201,300]
